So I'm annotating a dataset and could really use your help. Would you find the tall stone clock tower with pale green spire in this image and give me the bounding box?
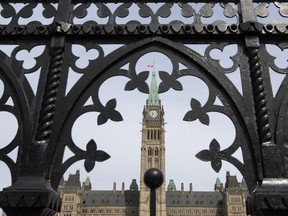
[139,71,166,216]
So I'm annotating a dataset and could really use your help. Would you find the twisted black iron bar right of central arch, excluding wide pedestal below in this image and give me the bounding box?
[240,0,283,181]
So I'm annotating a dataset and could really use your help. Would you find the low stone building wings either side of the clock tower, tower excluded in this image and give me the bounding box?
[57,171,248,216]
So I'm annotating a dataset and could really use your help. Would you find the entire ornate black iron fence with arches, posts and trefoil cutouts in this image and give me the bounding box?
[0,0,288,215]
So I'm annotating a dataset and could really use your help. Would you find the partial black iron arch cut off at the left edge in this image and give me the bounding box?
[0,51,32,182]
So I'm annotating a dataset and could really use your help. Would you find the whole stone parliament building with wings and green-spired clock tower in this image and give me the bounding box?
[57,72,248,216]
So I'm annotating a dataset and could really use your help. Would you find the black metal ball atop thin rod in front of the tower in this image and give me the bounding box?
[144,168,163,189]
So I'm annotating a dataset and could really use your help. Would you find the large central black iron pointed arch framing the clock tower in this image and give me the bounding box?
[49,36,262,191]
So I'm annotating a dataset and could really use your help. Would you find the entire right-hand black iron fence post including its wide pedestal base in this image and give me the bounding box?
[240,0,288,216]
